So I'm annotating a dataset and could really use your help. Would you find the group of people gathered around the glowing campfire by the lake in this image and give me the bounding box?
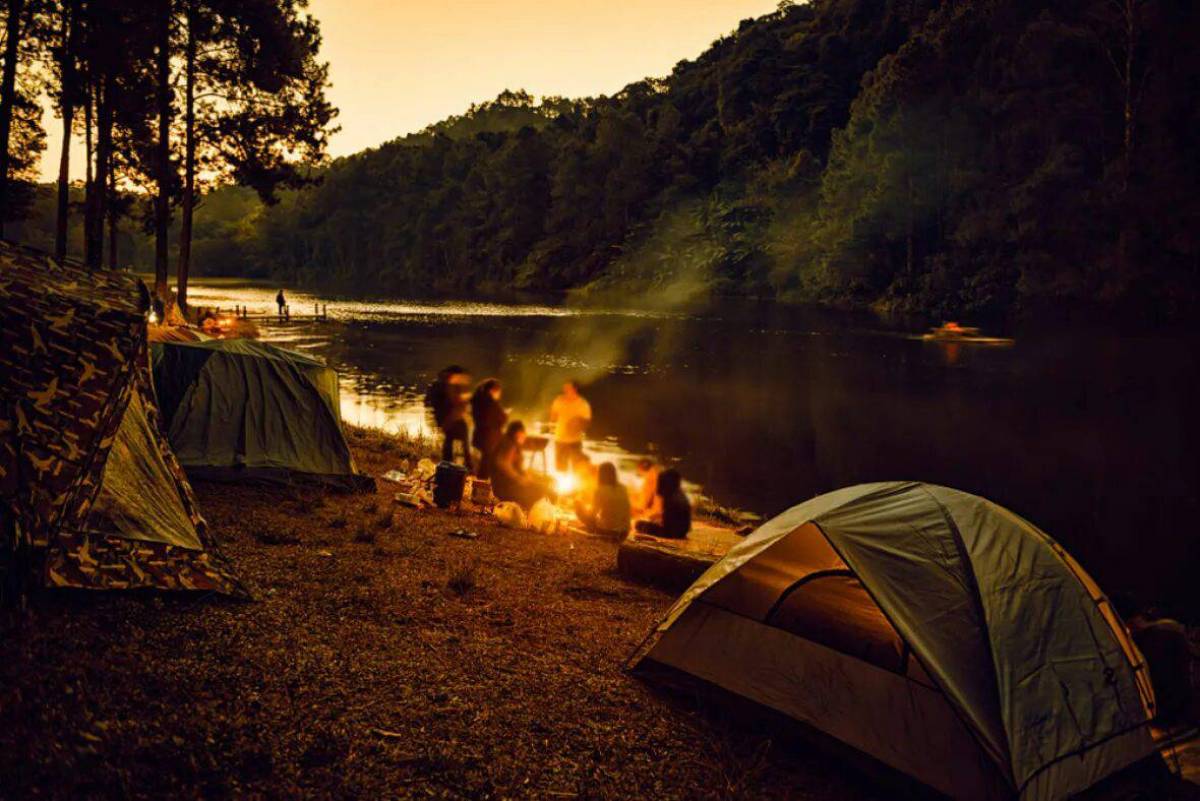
[425,365,691,538]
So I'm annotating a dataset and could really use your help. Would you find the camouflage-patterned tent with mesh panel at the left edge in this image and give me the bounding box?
[0,237,245,595]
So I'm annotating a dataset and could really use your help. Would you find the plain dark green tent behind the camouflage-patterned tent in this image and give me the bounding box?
[152,339,371,488]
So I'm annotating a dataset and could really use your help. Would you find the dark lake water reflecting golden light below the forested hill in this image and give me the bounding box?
[182,279,1200,612]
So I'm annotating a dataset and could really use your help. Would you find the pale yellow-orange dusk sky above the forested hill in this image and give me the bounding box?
[42,0,776,181]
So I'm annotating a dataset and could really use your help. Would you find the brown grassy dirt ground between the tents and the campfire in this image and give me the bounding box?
[0,432,896,800]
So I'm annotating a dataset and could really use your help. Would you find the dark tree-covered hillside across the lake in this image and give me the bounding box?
[18,0,1200,315]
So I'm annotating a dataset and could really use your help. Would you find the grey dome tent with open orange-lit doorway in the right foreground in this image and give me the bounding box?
[631,482,1154,801]
